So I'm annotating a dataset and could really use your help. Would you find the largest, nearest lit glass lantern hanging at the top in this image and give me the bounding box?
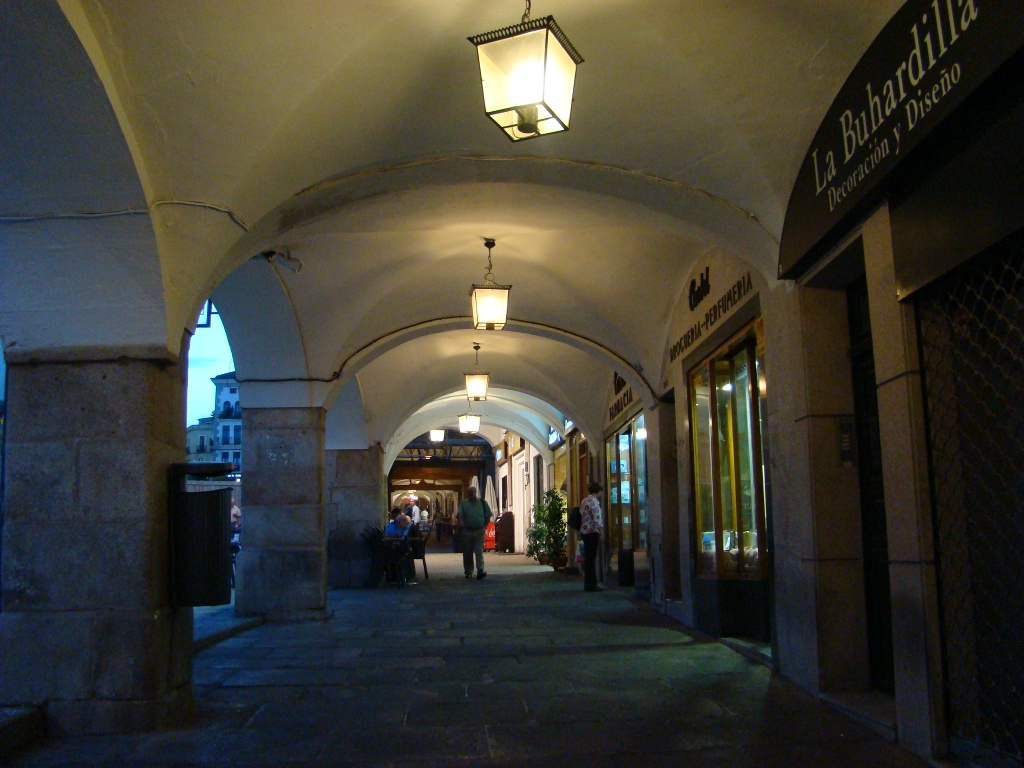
[468,0,583,141]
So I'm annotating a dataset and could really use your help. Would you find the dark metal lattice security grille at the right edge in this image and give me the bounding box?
[918,237,1024,766]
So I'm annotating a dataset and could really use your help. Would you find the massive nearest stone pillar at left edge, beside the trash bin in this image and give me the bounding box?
[0,359,193,733]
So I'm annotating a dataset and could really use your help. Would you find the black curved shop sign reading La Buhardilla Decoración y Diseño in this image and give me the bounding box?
[778,0,1024,279]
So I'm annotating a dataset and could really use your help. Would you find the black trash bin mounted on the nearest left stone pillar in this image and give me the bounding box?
[168,462,234,607]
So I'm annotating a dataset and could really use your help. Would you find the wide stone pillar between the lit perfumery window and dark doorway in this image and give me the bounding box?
[763,283,868,692]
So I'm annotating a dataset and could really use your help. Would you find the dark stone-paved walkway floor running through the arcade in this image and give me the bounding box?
[13,553,925,768]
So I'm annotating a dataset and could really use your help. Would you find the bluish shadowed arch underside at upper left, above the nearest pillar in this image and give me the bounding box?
[0,3,163,360]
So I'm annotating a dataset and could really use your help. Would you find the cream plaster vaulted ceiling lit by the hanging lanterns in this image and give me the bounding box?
[0,0,901,444]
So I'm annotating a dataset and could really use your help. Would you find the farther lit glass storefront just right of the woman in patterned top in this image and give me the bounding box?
[605,414,647,552]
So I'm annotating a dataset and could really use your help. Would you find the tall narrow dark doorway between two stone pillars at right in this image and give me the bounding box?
[847,276,895,693]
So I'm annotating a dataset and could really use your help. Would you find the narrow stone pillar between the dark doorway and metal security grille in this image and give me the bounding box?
[862,207,945,756]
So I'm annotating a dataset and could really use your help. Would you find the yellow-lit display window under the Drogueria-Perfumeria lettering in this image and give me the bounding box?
[689,322,767,579]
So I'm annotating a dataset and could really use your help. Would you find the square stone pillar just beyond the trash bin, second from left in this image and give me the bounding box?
[234,408,327,621]
